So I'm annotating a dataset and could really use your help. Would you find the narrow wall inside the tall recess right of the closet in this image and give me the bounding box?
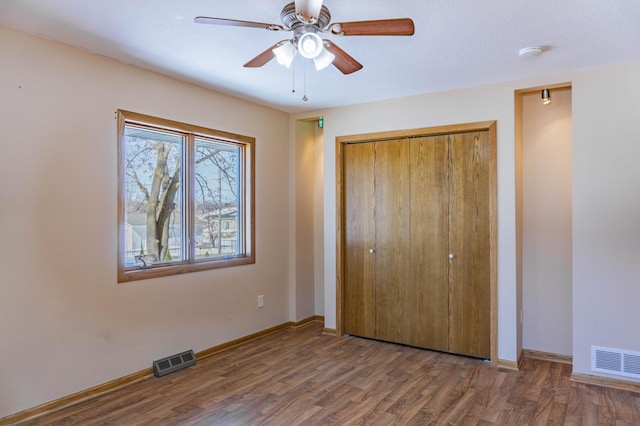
[522,88,573,356]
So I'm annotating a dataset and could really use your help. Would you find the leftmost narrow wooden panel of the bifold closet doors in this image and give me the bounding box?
[342,142,376,338]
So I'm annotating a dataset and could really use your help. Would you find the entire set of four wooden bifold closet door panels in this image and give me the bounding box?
[341,125,492,359]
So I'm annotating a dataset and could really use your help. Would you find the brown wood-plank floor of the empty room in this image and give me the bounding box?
[16,324,640,426]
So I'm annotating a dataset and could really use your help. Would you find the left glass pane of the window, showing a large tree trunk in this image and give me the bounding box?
[123,125,185,266]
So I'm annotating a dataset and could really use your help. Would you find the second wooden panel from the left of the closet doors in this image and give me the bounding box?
[375,139,413,344]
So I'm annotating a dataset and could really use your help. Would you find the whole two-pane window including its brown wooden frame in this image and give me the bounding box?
[118,110,255,282]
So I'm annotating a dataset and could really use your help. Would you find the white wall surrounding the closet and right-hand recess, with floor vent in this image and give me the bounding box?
[292,63,640,374]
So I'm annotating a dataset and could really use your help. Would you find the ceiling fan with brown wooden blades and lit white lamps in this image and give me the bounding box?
[194,0,414,74]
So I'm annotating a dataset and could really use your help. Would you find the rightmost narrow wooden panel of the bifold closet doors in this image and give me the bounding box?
[449,132,491,359]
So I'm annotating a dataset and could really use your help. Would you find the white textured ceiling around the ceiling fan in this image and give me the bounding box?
[0,0,640,112]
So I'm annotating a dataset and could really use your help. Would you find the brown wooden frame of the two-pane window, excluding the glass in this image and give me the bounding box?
[117,109,256,283]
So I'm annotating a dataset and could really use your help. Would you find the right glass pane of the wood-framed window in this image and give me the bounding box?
[194,138,244,259]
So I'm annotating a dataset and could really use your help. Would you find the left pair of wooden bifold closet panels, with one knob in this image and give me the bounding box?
[343,140,412,343]
